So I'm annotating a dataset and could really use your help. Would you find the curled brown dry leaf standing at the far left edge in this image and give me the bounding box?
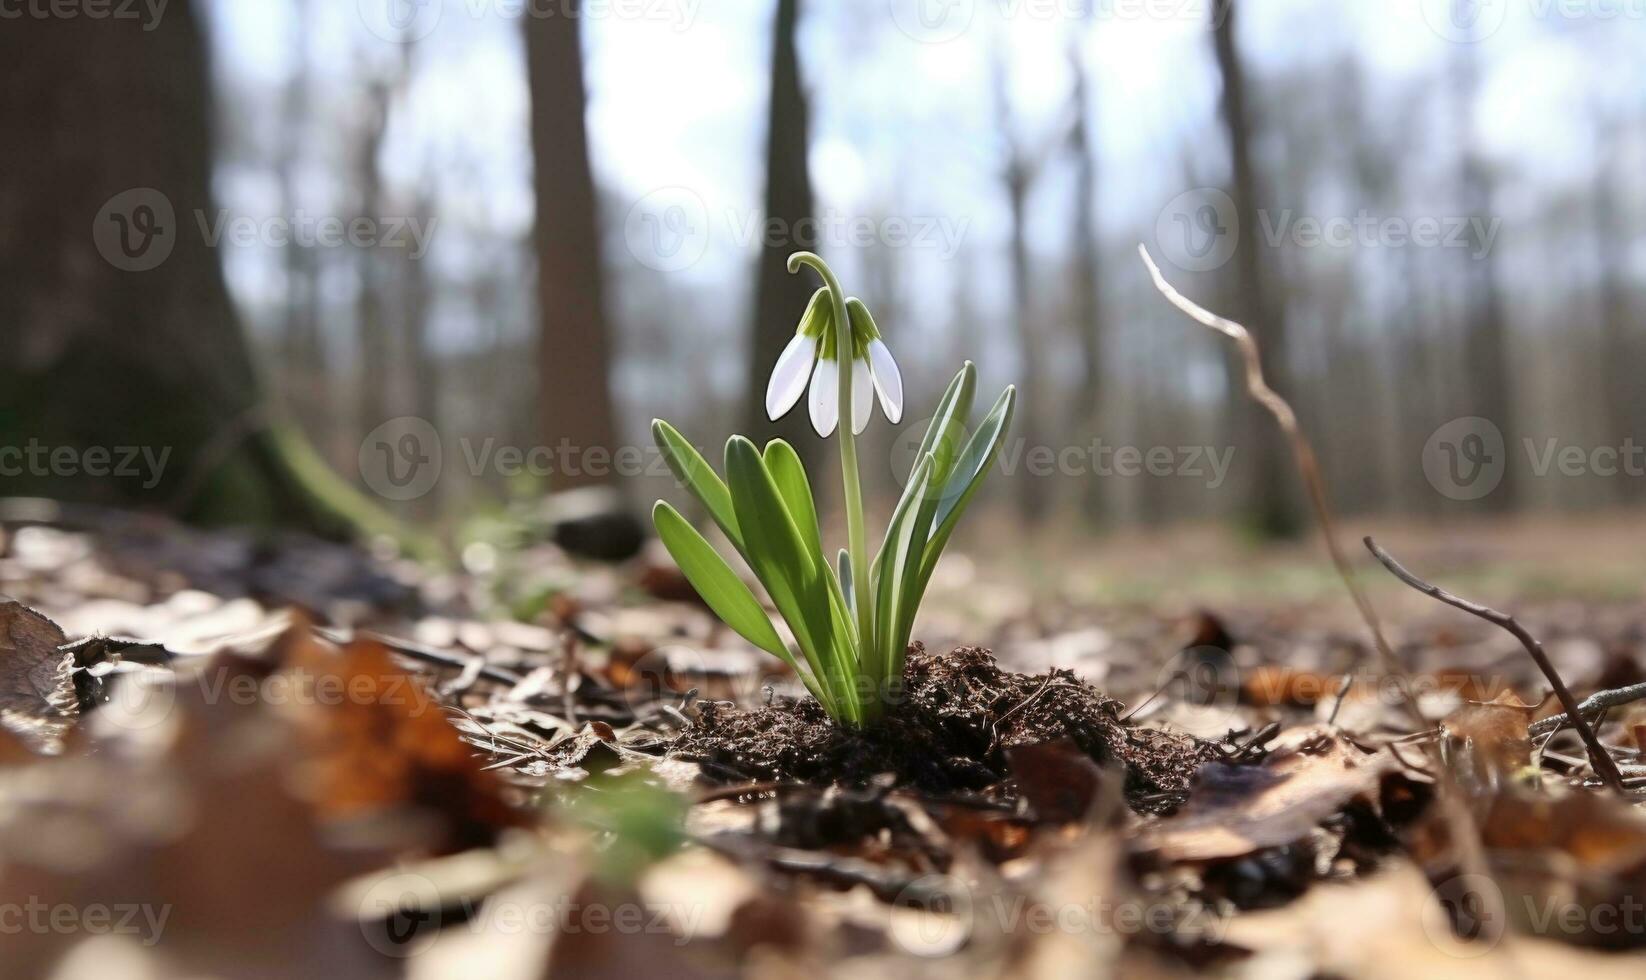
[0,601,79,753]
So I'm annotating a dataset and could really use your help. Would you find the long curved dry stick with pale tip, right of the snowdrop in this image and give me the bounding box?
[1137,245,1429,730]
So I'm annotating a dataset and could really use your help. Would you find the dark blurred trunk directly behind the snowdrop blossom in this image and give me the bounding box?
[744,0,819,471]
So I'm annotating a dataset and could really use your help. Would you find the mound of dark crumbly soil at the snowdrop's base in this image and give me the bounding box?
[672,644,1208,812]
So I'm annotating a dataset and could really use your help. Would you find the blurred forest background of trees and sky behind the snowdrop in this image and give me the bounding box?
[0,0,1646,563]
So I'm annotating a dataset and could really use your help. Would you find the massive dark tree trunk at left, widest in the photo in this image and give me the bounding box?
[0,3,344,532]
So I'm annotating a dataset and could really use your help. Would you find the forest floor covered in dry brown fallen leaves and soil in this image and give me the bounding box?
[0,502,1646,980]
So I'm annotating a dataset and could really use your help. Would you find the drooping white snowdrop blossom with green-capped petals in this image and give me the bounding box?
[765,288,904,436]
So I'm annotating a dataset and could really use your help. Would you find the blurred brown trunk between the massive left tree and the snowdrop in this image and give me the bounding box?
[522,0,617,488]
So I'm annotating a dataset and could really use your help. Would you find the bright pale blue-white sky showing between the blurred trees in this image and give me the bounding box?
[209,0,1646,372]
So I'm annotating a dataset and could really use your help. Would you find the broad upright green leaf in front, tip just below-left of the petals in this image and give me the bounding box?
[726,435,859,721]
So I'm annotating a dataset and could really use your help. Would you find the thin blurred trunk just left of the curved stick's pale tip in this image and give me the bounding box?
[1068,24,1104,517]
